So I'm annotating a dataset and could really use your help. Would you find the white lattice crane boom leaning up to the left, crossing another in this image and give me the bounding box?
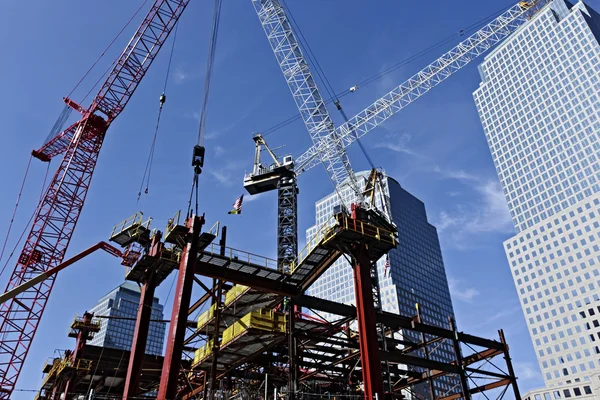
[252,0,361,195]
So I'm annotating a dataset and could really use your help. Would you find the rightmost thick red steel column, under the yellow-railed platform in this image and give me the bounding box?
[352,243,383,400]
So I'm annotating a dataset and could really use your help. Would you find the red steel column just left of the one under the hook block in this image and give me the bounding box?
[123,232,163,400]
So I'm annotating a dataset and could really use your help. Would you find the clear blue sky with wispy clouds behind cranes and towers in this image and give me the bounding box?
[0,0,598,399]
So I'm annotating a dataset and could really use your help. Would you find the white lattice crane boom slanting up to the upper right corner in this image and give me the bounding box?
[296,0,548,175]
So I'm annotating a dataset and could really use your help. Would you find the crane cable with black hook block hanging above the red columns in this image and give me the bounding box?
[187,0,223,217]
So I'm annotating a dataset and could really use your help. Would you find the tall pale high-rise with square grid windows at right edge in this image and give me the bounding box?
[474,0,600,400]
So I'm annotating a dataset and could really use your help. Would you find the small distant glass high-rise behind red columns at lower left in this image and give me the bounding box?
[89,281,167,356]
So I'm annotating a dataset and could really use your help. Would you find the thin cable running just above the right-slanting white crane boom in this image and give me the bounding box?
[261,2,514,137]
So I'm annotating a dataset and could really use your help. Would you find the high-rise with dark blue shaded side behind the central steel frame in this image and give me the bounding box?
[306,172,457,396]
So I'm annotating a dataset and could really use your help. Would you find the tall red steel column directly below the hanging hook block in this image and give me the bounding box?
[157,215,204,400]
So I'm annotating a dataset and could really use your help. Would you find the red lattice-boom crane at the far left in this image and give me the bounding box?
[0,0,189,399]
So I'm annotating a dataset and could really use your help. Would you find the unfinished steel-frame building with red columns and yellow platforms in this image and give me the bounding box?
[32,207,519,399]
